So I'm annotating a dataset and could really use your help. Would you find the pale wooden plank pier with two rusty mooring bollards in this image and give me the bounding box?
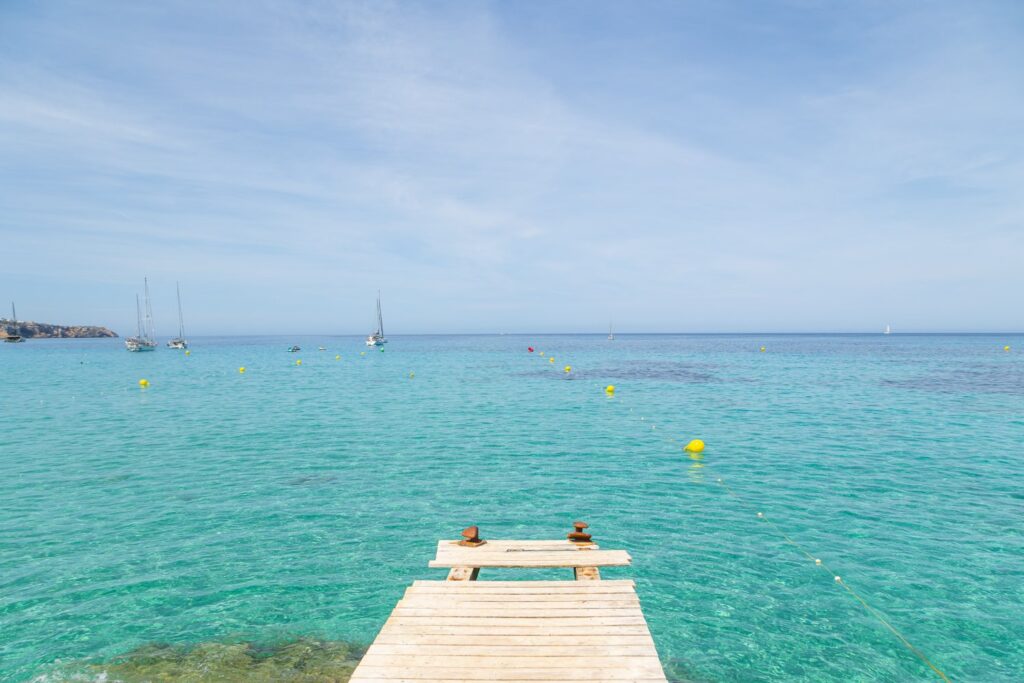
[350,523,667,683]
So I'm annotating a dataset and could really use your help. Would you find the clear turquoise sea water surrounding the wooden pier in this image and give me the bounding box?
[0,335,1024,682]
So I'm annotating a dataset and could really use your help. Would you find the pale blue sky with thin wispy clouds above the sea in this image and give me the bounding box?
[0,0,1024,336]
